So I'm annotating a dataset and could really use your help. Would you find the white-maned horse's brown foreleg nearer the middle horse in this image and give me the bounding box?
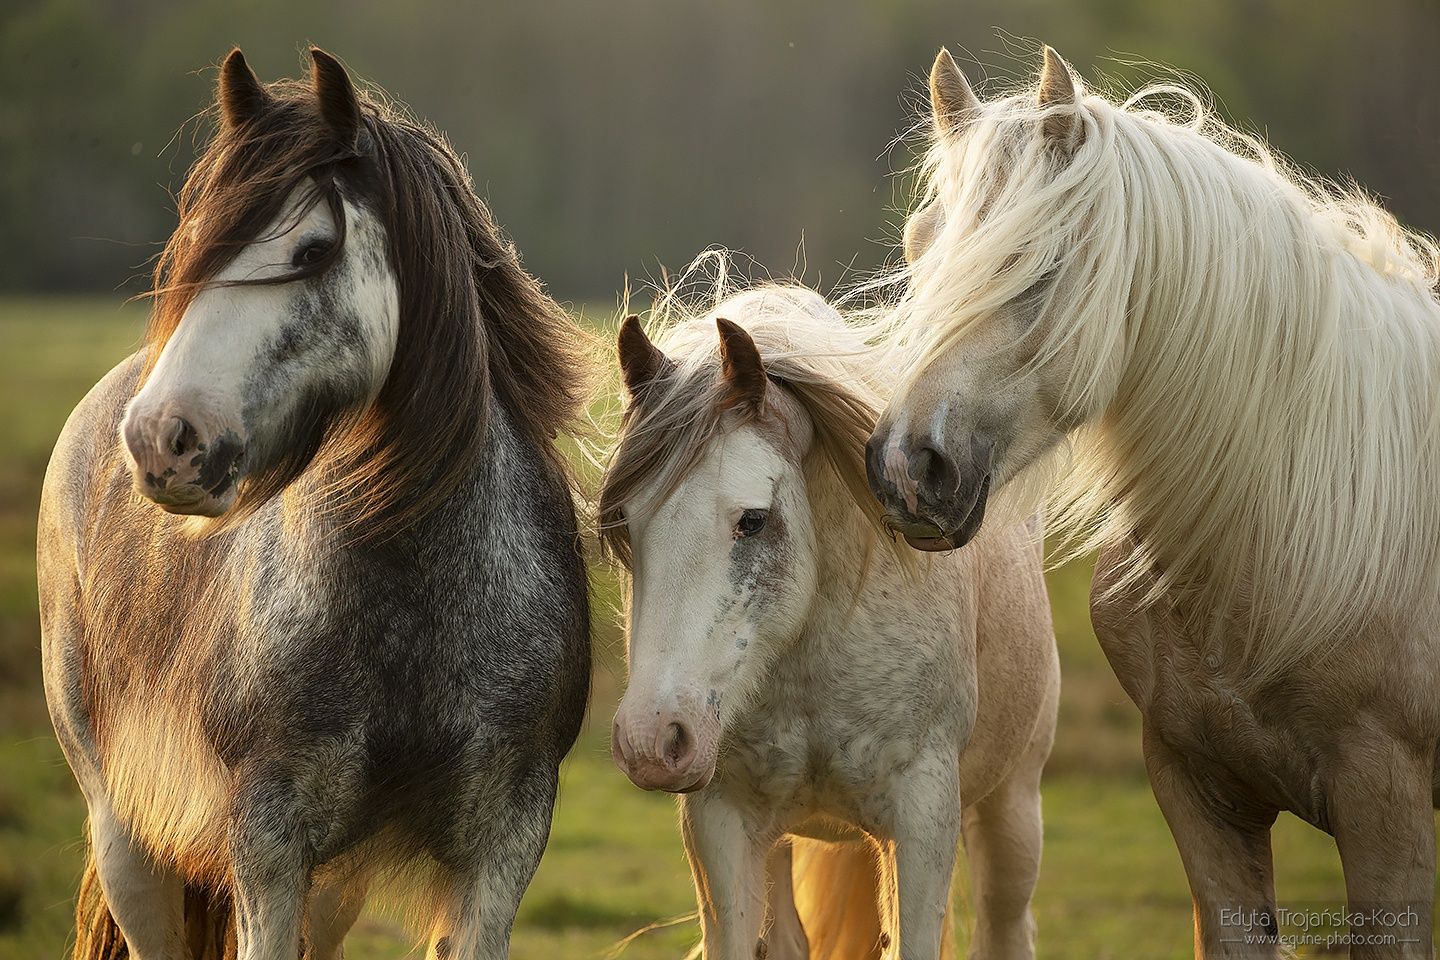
[1145,735,1280,960]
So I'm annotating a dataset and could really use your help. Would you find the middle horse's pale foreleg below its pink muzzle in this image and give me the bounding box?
[680,793,770,960]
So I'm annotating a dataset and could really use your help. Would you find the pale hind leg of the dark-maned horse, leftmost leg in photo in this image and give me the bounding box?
[89,800,186,960]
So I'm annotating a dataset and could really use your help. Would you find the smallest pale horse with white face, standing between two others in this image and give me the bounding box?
[599,286,1058,960]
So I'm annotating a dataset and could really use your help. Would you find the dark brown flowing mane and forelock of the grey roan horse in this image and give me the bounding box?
[143,54,588,538]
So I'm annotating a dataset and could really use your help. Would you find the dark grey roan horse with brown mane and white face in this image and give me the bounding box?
[39,49,590,960]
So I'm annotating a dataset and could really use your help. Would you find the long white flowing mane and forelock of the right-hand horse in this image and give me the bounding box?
[891,71,1440,679]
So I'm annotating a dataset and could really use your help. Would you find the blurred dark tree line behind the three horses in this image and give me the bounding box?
[0,0,1440,299]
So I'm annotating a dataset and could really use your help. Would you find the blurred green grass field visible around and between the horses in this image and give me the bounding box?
[0,298,1393,960]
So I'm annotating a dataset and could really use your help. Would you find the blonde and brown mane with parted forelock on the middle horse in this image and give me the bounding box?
[599,273,886,566]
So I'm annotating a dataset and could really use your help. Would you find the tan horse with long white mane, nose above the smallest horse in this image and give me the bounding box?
[867,47,1440,957]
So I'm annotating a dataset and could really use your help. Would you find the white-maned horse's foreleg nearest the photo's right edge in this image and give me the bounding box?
[1328,733,1436,960]
